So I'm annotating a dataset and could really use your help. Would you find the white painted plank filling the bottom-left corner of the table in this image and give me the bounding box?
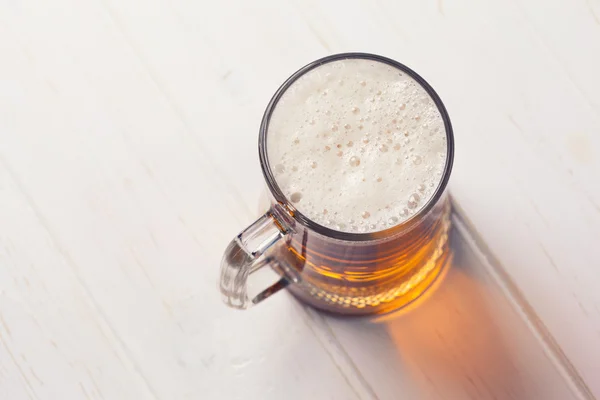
[0,166,155,400]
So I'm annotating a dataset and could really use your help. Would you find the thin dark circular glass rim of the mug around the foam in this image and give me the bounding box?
[258,53,454,241]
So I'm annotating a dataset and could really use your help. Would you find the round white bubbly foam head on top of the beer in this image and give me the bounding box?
[267,59,447,233]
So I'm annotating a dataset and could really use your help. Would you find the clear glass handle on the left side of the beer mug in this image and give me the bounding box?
[219,204,297,309]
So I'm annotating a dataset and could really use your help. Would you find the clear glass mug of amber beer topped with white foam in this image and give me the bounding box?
[220,53,454,315]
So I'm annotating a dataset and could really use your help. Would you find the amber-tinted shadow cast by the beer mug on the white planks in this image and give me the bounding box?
[310,229,574,400]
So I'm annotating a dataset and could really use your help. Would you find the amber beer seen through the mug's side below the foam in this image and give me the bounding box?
[281,197,451,314]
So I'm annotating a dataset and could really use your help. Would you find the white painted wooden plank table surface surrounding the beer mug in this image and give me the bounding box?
[0,0,600,400]
